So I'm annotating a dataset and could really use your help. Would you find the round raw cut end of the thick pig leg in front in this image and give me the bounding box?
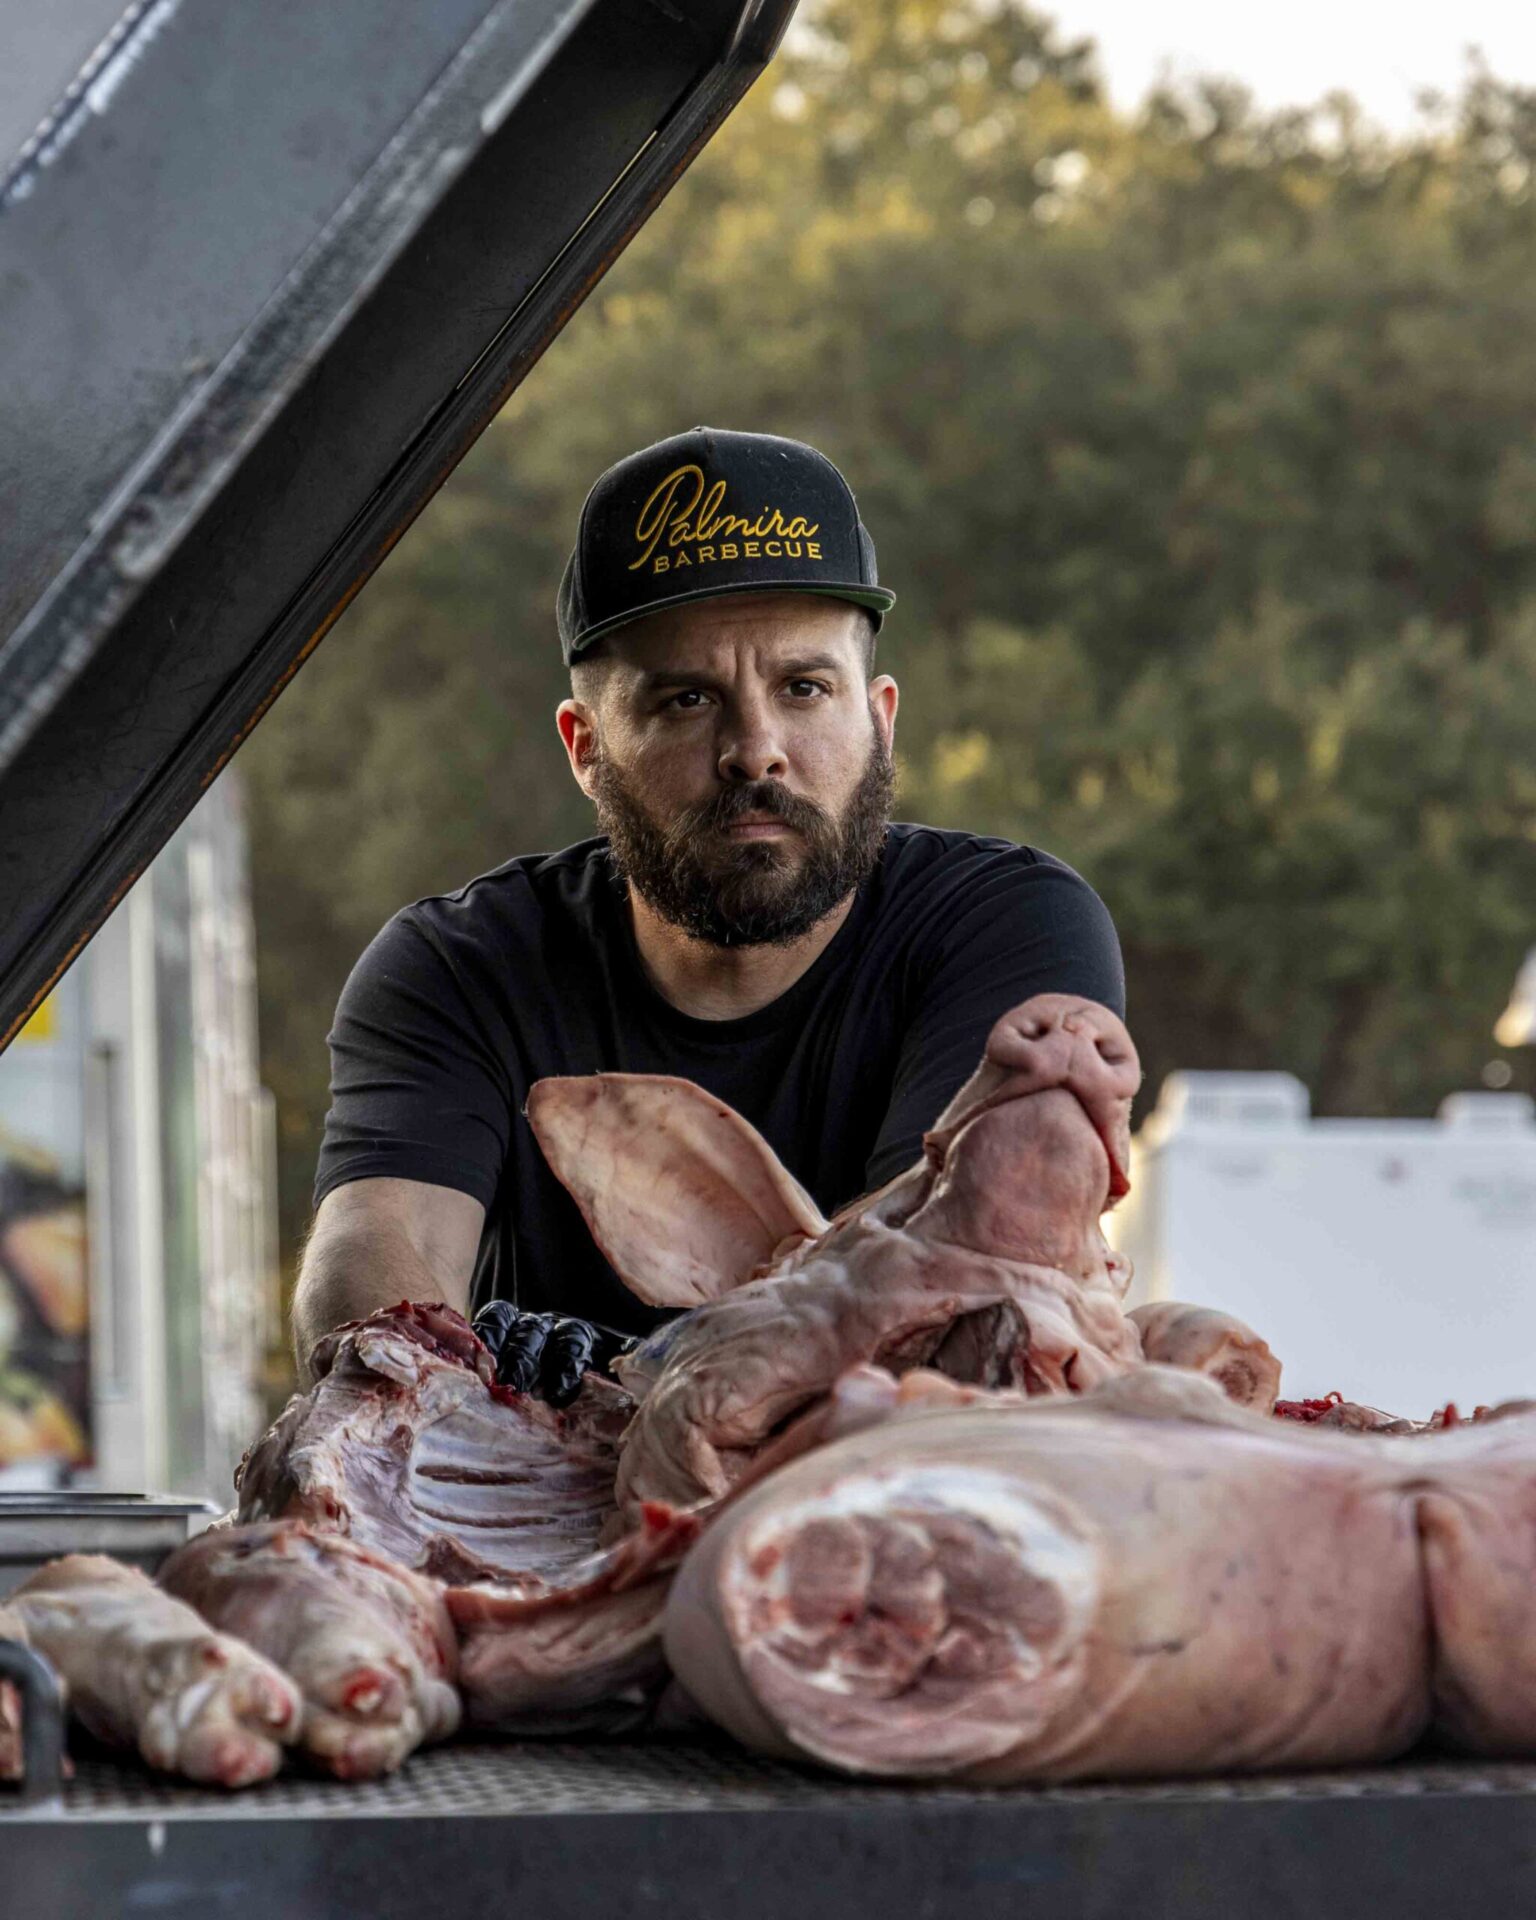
[666,1469,1102,1774]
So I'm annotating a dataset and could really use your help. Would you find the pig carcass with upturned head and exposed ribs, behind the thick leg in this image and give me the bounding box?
[210,995,1274,1732]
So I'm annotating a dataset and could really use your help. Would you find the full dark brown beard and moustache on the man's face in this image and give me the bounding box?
[589,722,897,947]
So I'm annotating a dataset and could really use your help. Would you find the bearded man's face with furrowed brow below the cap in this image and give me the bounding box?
[561,593,897,947]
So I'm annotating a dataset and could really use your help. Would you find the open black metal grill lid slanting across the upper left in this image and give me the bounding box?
[0,0,793,1044]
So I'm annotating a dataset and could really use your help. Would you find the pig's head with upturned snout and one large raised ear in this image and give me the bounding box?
[528,995,1279,1524]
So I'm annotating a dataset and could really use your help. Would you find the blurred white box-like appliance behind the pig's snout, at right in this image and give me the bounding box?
[1106,1073,1536,1419]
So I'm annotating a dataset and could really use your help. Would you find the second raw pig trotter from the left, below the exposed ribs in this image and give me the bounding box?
[159,1521,459,1780]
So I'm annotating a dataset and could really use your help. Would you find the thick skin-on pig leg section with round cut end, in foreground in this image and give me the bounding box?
[666,1367,1536,1782]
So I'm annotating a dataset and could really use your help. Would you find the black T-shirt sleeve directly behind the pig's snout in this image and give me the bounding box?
[866,849,1125,1192]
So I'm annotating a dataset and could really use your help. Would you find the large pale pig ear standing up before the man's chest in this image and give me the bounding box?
[528,1073,828,1308]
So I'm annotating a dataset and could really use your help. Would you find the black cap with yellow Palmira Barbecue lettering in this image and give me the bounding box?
[559,426,897,666]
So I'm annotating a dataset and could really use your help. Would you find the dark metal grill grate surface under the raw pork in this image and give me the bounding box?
[27,1741,1536,1822]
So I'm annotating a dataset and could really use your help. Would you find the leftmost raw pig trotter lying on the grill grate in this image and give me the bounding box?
[8,1553,301,1788]
